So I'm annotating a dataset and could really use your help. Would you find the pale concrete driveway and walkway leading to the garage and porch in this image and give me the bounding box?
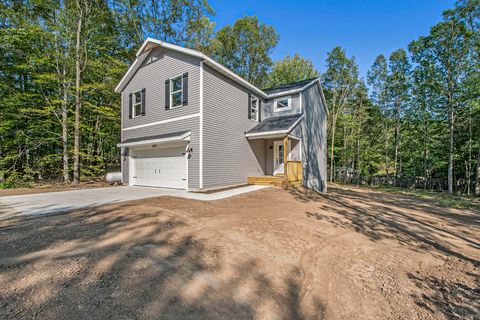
[0,186,264,220]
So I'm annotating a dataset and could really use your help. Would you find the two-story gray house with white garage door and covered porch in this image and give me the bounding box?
[115,38,328,191]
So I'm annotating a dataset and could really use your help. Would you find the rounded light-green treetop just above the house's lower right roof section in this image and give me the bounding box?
[267,53,319,87]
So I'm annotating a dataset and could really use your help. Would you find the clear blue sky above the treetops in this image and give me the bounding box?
[209,0,455,77]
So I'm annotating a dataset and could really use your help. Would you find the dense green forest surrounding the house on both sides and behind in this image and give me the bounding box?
[0,0,480,195]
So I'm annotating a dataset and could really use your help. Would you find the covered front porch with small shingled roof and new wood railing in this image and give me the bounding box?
[245,115,303,186]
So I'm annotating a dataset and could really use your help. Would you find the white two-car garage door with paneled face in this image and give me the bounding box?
[133,146,187,189]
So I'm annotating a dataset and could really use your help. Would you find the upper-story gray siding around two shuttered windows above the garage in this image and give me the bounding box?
[122,48,200,128]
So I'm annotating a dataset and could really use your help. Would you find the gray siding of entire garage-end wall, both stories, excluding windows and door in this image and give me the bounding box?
[122,48,200,189]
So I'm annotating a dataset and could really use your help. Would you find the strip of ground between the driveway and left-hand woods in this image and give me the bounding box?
[0,181,120,197]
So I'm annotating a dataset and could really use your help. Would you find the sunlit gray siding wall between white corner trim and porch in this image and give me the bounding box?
[203,66,265,188]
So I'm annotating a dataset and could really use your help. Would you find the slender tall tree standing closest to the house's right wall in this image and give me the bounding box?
[323,47,358,182]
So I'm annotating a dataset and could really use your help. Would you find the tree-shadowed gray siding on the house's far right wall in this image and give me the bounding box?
[294,84,327,191]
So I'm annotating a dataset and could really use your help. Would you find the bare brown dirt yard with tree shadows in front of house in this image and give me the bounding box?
[0,186,480,319]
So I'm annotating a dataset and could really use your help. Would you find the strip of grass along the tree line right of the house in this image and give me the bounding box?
[350,186,480,210]
